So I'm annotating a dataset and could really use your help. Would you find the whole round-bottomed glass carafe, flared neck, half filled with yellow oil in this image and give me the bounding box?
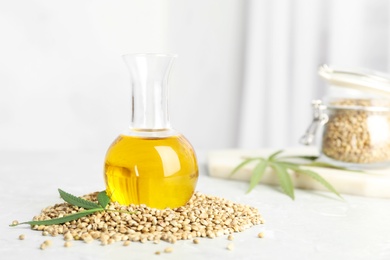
[104,54,198,209]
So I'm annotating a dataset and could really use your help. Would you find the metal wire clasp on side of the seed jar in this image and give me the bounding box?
[299,100,329,145]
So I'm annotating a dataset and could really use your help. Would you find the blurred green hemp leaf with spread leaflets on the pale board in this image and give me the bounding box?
[230,150,358,199]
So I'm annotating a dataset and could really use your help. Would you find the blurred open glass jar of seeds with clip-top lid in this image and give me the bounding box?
[301,65,390,168]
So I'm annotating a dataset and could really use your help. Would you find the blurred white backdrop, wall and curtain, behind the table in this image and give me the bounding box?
[0,0,390,152]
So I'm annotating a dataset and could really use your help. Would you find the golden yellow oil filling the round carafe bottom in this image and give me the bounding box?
[104,135,198,209]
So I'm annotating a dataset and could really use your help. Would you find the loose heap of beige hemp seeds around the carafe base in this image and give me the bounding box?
[15,192,264,251]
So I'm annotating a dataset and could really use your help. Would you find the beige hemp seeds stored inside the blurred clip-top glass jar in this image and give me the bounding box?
[322,99,390,164]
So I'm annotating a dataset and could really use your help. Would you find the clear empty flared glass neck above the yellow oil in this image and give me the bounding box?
[123,54,176,132]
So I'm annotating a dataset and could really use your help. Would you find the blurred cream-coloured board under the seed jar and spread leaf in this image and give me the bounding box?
[207,147,390,198]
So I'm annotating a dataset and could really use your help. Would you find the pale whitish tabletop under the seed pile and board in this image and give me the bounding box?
[0,152,390,260]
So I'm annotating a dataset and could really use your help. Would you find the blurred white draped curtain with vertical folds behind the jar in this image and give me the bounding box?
[238,0,389,148]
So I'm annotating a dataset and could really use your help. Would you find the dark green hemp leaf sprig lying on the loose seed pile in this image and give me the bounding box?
[10,189,134,227]
